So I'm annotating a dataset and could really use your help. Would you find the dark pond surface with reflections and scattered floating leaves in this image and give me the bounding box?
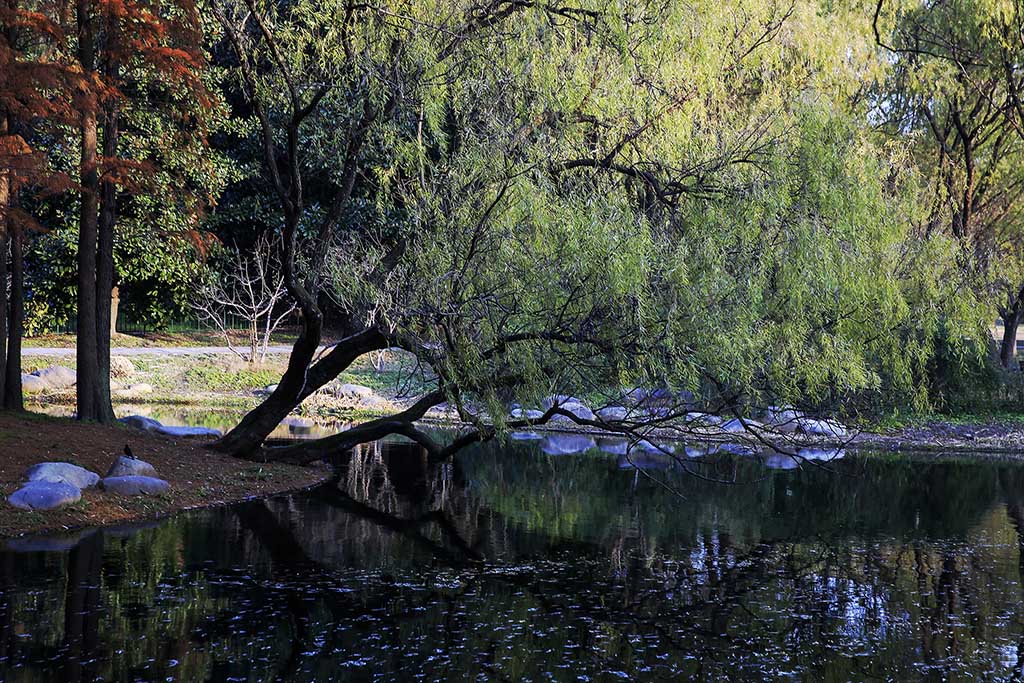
[0,442,1024,681]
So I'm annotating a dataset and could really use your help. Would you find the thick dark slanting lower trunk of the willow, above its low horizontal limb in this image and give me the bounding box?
[213,328,388,458]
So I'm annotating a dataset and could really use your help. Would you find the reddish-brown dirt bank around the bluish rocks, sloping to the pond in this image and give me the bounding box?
[0,413,328,538]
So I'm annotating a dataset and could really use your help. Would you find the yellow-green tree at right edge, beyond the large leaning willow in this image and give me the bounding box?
[873,0,1024,368]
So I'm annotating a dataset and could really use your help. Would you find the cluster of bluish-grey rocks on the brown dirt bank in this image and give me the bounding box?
[7,456,170,510]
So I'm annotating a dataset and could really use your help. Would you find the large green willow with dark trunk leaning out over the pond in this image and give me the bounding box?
[209,0,966,462]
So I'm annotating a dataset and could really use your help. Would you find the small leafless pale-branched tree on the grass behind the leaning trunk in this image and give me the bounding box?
[191,236,297,365]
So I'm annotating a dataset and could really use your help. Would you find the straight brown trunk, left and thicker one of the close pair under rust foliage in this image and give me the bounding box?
[76,0,102,420]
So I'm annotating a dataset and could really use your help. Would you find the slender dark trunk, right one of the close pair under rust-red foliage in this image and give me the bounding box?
[96,108,119,423]
